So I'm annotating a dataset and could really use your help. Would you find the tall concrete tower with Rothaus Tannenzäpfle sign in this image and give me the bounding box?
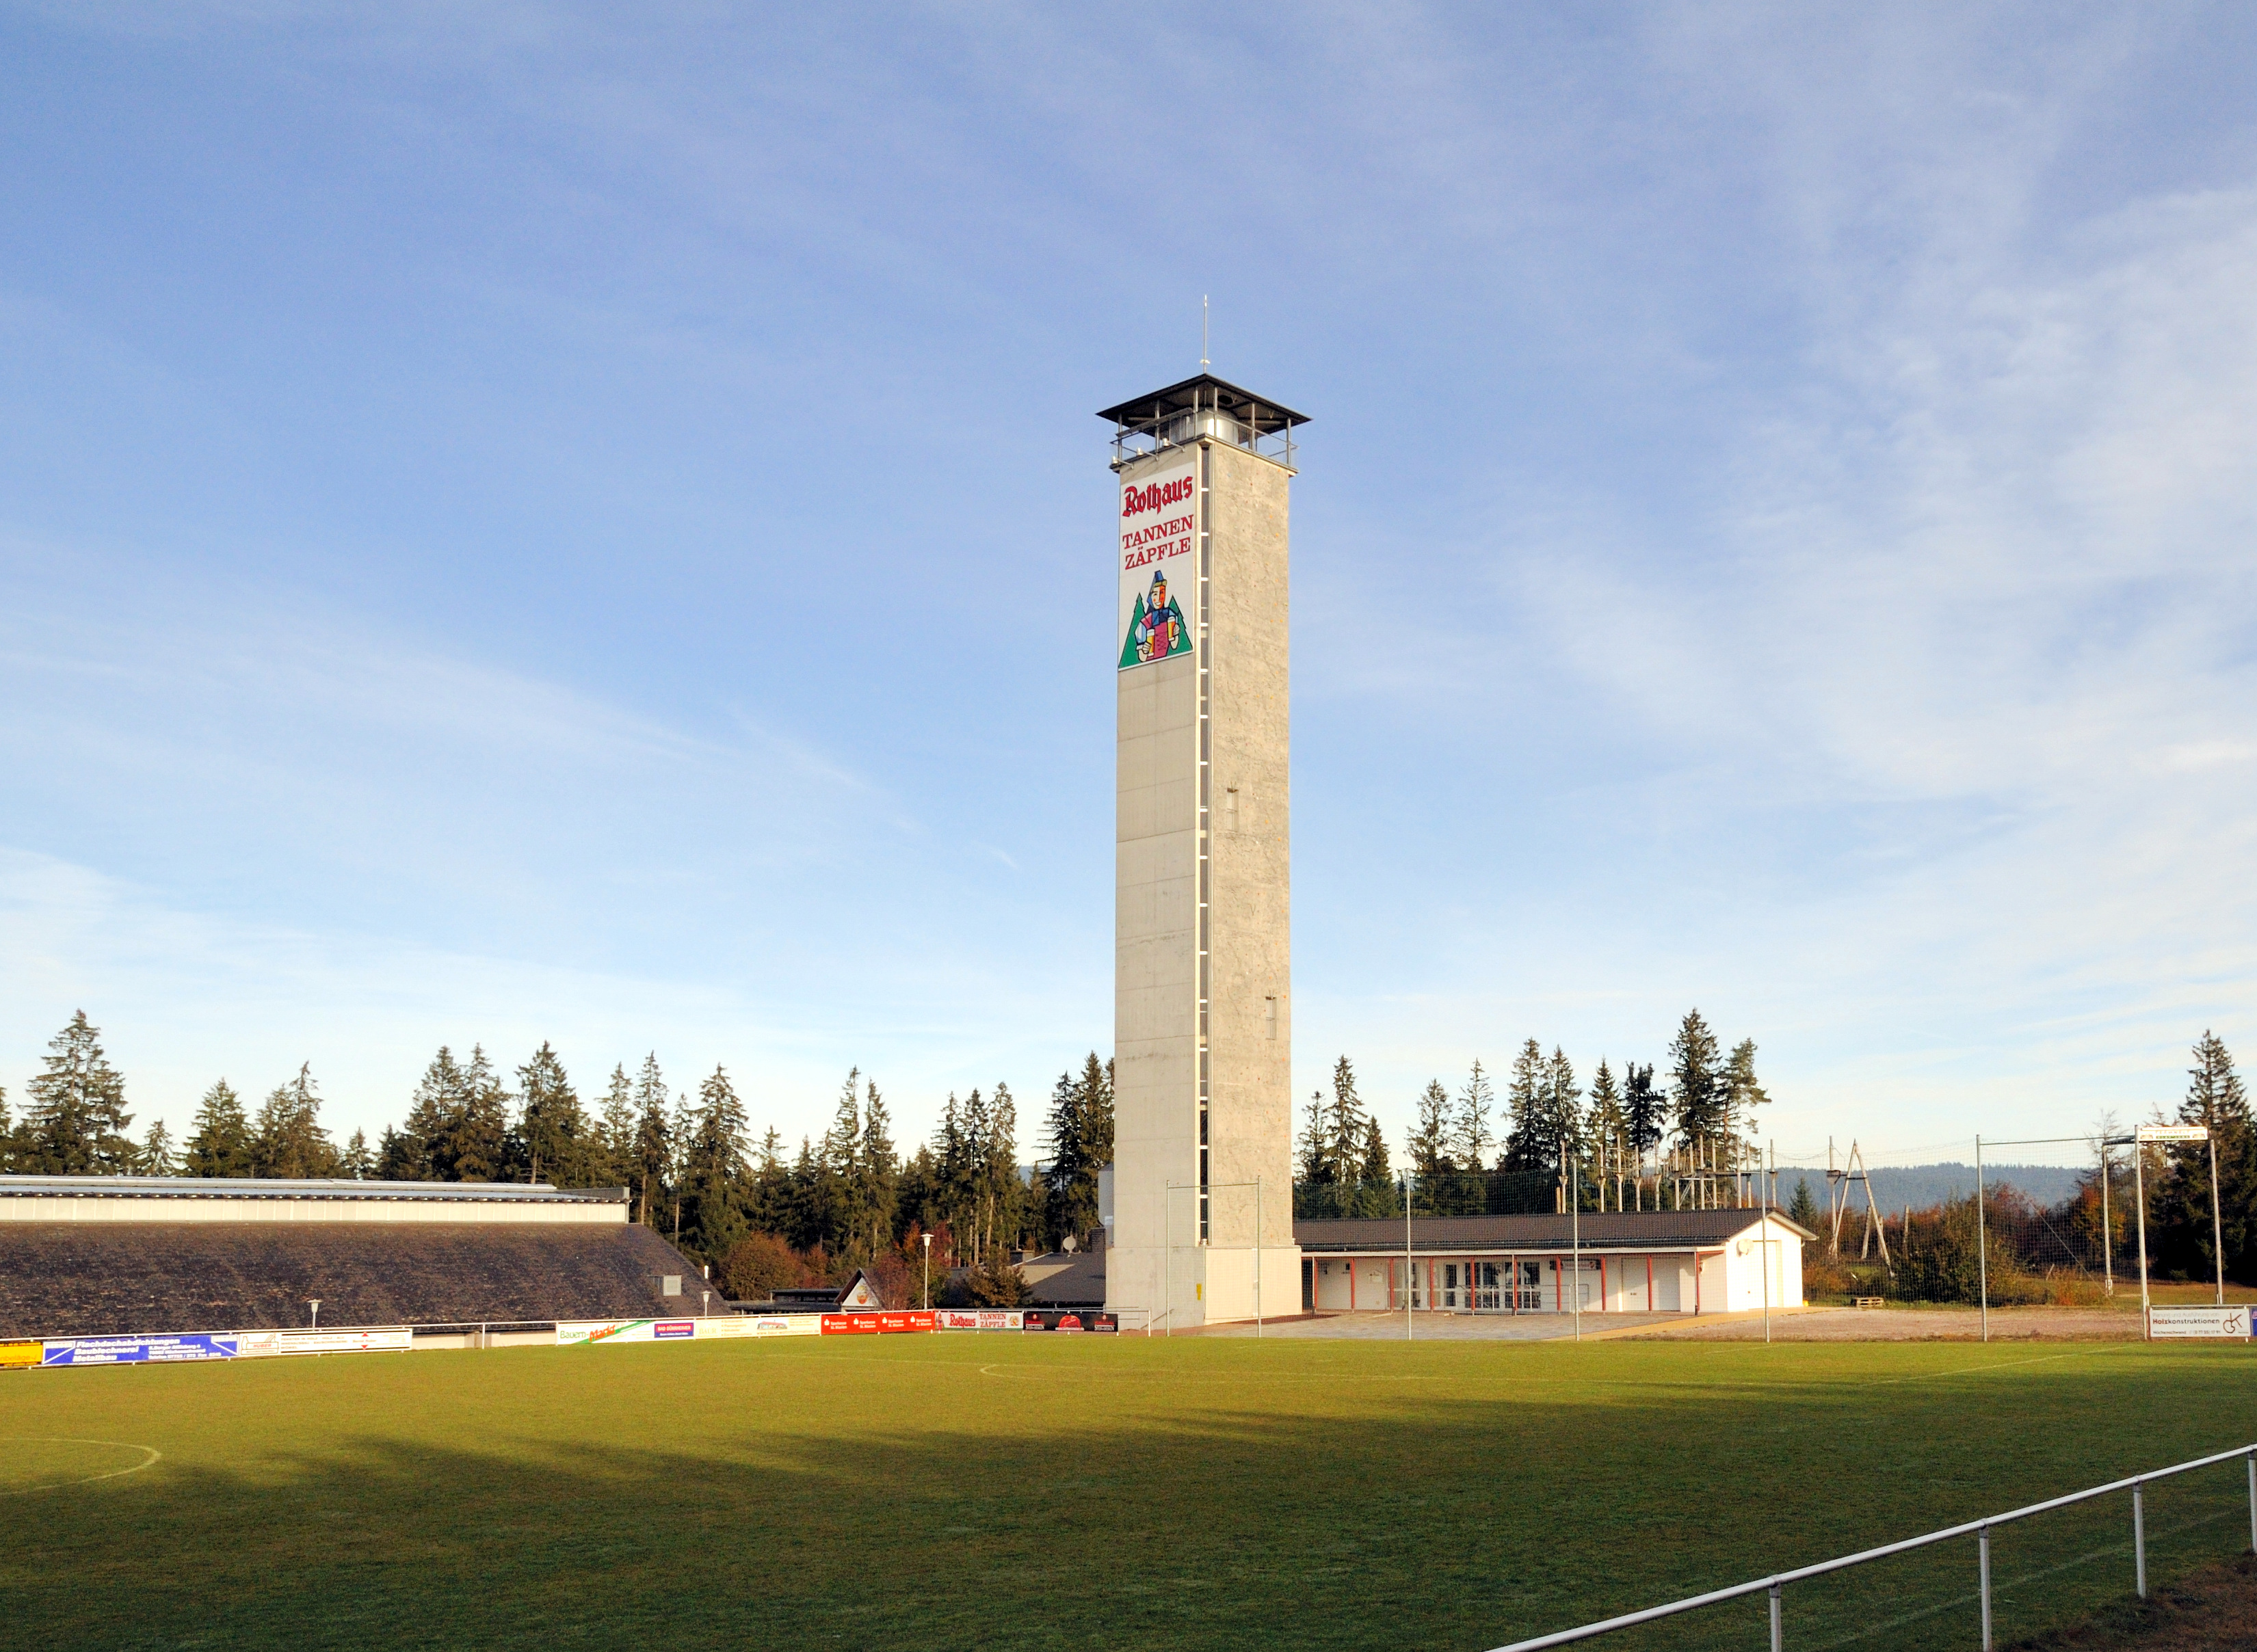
[1099,373,1307,1329]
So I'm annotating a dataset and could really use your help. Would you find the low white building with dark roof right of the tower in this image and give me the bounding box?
[1293,1208,1817,1314]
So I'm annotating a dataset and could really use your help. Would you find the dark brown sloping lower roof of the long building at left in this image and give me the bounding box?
[0,1221,720,1336]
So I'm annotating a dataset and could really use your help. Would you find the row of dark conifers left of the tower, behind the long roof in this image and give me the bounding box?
[0,1011,1113,1300]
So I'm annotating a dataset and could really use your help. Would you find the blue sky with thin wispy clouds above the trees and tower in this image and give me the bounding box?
[0,2,2257,1162]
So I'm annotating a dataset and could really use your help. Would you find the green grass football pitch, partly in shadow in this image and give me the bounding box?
[0,1336,2257,1652]
